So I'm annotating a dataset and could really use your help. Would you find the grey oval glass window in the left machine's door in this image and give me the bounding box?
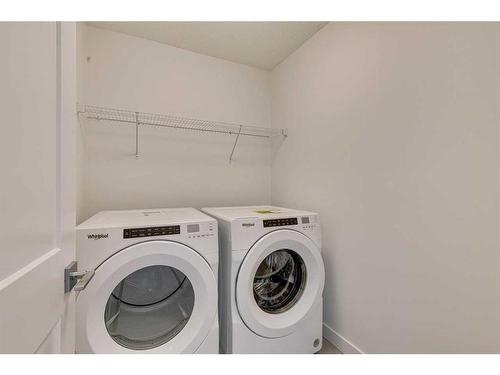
[104,265,194,350]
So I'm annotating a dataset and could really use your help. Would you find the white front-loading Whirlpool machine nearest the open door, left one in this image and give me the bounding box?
[76,208,219,354]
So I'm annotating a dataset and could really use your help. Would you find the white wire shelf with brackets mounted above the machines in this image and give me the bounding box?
[78,105,287,161]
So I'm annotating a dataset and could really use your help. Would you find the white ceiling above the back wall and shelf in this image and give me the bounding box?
[88,22,326,70]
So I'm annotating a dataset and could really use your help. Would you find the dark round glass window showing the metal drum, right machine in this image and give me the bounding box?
[253,249,307,314]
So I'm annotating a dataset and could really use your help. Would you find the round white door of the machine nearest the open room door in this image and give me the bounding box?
[76,241,217,354]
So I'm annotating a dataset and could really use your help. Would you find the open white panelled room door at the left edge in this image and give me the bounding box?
[0,22,76,353]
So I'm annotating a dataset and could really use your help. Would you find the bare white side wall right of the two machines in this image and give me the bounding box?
[272,23,500,353]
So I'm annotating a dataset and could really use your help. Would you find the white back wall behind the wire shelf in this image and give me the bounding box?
[78,26,271,221]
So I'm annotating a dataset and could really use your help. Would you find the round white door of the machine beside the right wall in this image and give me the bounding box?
[236,229,325,338]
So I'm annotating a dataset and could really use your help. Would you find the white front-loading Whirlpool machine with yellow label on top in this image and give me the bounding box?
[203,206,325,353]
